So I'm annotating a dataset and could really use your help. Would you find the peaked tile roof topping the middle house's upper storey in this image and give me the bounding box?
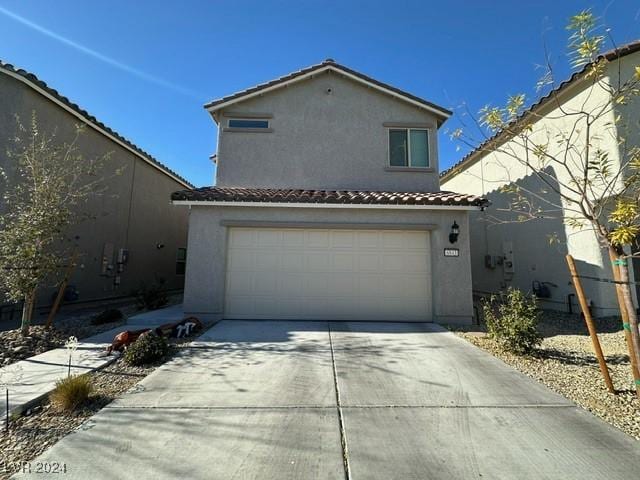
[205,58,453,120]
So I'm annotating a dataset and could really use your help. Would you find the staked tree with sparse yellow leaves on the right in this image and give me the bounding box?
[452,10,640,395]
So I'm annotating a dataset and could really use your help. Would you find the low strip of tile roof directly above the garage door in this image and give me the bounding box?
[171,187,489,207]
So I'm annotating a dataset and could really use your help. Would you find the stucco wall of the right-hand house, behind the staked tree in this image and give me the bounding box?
[442,55,640,316]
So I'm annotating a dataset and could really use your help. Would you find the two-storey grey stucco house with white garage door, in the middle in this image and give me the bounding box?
[172,60,486,323]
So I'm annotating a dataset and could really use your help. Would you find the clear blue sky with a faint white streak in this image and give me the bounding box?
[0,0,640,186]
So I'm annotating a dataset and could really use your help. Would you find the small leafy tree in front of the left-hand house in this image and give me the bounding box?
[0,112,109,335]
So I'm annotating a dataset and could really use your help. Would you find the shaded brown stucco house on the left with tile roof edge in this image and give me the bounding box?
[0,62,191,312]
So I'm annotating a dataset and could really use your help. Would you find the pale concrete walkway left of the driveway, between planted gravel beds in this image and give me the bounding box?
[0,305,182,418]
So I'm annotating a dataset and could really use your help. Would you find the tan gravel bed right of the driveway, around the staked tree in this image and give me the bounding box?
[454,312,640,440]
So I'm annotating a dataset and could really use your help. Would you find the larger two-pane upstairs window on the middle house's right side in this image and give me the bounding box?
[389,128,429,168]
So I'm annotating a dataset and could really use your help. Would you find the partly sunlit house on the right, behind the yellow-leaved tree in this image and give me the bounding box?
[440,41,640,316]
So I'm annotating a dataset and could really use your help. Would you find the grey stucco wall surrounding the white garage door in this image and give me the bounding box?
[184,206,473,323]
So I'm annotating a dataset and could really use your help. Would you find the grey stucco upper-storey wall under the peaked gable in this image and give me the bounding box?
[216,72,439,191]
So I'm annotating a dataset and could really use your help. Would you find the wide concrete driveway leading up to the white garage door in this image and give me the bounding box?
[15,321,640,480]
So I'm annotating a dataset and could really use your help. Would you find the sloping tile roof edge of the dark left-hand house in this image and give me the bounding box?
[0,60,193,187]
